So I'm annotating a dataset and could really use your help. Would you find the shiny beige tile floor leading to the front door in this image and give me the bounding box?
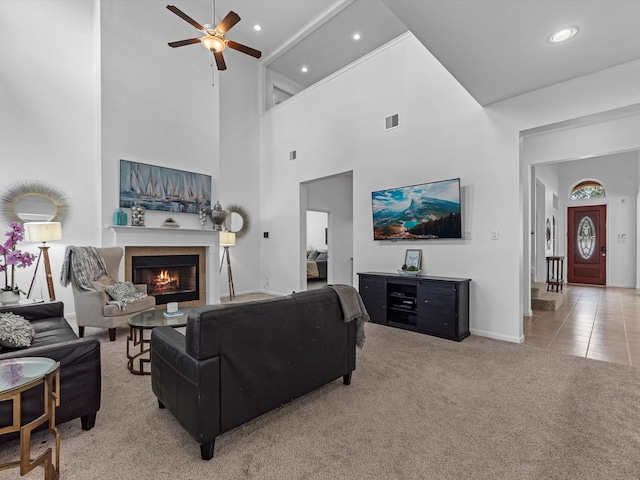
[523,285,640,367]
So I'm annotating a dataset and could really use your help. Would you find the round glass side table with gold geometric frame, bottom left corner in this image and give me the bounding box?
[0,357,60,480]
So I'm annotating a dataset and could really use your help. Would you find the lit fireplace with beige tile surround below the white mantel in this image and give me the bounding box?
[125,247,206,306]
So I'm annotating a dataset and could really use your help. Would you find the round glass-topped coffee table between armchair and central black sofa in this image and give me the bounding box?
[127,307,194,375]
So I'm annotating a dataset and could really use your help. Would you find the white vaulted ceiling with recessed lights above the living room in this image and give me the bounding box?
[186,0,640,105]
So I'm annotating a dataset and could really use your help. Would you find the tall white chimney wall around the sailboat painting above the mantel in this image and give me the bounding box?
[100,0,220,240]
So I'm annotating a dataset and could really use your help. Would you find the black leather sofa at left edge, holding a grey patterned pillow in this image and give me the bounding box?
[0,302,101,443]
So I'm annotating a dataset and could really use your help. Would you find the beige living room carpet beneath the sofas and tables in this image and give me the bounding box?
[0,324,640,480]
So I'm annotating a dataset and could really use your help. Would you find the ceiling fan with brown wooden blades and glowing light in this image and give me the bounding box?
[167,5,262,70]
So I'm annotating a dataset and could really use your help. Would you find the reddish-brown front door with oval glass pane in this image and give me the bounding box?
[567,205,607,285]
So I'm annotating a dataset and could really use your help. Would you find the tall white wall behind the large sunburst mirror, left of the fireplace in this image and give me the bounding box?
[0,0,100,312]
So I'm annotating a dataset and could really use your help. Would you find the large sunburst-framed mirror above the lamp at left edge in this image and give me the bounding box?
[0,181,69,223]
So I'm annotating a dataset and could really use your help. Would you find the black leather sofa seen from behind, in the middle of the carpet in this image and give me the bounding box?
[151,288,356,460]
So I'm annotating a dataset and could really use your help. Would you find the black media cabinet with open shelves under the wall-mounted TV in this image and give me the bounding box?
[358,272,471,342]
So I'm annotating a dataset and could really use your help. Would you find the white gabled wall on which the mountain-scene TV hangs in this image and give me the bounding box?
[261,35,522,341]
